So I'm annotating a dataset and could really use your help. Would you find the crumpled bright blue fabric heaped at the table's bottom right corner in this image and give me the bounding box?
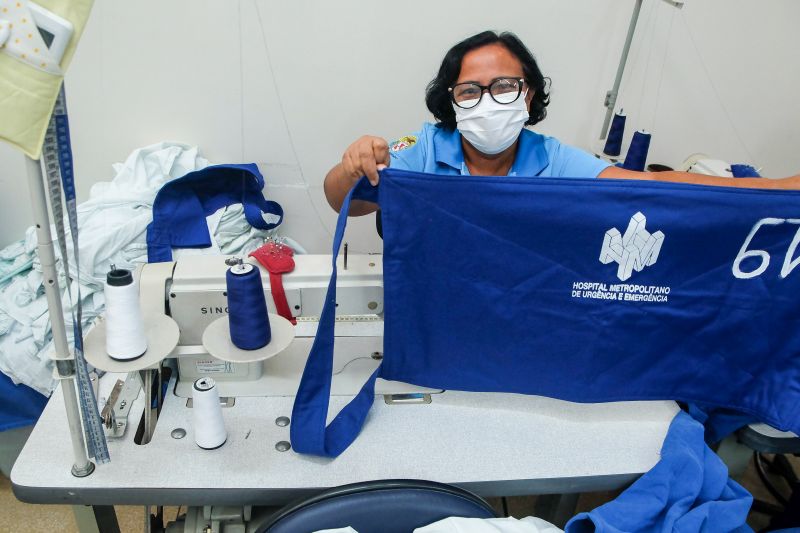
[565,411,753,533]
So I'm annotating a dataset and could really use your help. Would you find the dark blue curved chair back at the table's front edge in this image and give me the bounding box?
[258,479,497,533]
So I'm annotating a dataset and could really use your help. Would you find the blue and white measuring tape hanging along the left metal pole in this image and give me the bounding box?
[42,84,110,463]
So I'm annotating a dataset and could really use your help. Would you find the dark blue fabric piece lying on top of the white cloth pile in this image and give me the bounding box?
[147,163,283,263]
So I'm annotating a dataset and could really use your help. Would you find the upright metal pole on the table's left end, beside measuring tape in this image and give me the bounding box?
[25,157,94,477]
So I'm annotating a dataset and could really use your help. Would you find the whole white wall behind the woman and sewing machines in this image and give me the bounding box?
[0,0,800,253]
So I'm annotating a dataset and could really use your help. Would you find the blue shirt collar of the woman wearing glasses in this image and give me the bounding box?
[433,127,548,176]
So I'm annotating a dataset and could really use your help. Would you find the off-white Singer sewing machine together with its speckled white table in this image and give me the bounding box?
[11,250,677,531]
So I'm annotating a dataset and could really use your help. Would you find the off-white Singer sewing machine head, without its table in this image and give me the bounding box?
[154,254,430,397]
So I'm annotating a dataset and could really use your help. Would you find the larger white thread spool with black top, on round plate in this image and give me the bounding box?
[103,265,147,361]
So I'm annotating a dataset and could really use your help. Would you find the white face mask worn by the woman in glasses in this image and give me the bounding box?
[453,92,529,155]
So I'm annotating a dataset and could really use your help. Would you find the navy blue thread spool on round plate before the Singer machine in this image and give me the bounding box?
[225,263,272,350]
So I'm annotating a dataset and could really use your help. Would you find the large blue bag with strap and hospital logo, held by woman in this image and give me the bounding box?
[291,169,800,457]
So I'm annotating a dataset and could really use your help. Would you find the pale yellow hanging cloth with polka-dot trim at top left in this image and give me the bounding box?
[0,0,93,159]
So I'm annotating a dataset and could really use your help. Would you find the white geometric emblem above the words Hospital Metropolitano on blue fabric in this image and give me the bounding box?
[600,212,664,281]
